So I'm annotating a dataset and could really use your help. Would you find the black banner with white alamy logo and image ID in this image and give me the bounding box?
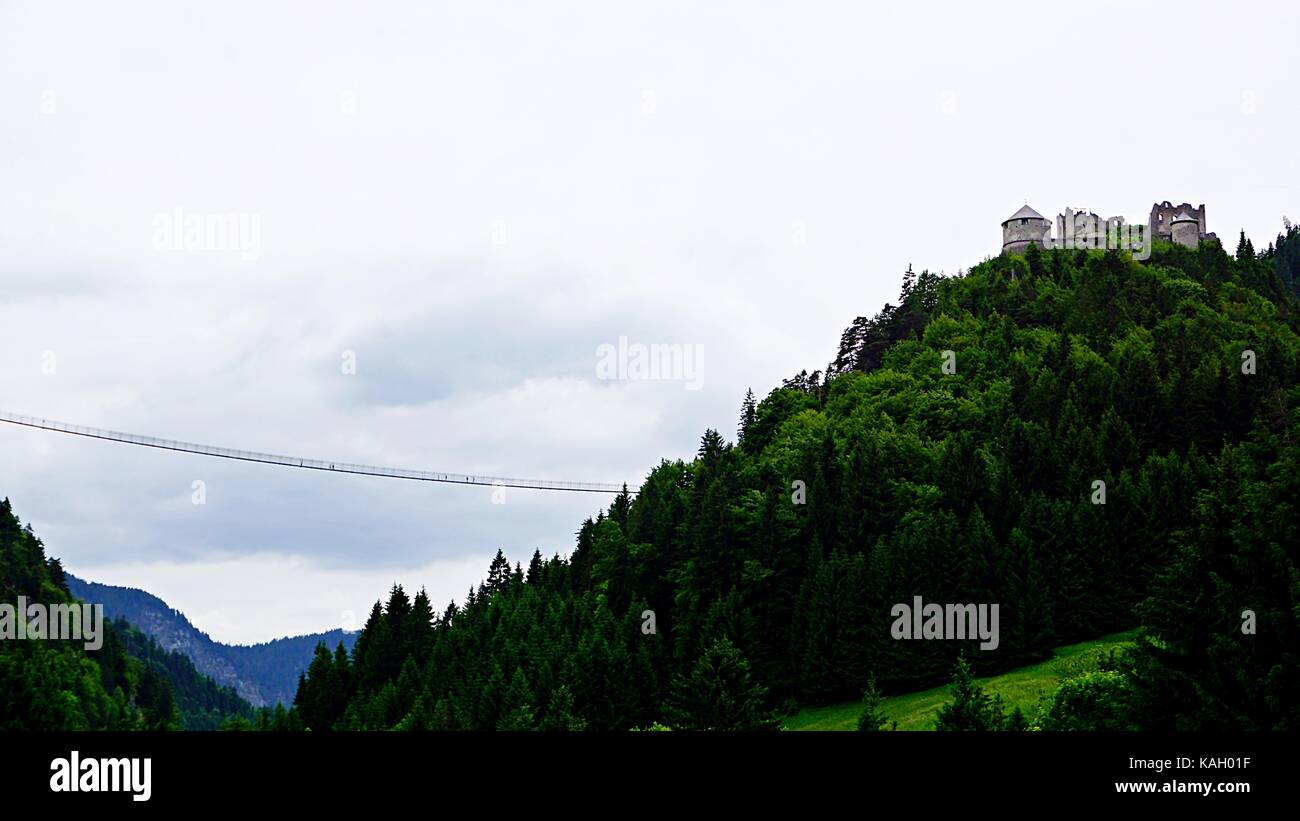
[0,733,1279,812]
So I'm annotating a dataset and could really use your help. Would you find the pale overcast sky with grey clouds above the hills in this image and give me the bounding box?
[0,0,1300,643]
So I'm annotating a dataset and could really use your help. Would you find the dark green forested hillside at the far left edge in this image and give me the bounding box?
[0,499,252,730]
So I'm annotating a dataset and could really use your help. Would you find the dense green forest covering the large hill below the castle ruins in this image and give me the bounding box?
[287,235,1300,731]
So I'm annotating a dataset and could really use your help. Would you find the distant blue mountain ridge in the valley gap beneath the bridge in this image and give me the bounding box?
[66,573,358,707]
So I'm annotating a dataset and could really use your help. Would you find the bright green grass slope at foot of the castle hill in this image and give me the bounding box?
[785,631,1136,730]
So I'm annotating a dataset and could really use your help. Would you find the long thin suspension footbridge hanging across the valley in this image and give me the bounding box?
[0,411,634,494]
